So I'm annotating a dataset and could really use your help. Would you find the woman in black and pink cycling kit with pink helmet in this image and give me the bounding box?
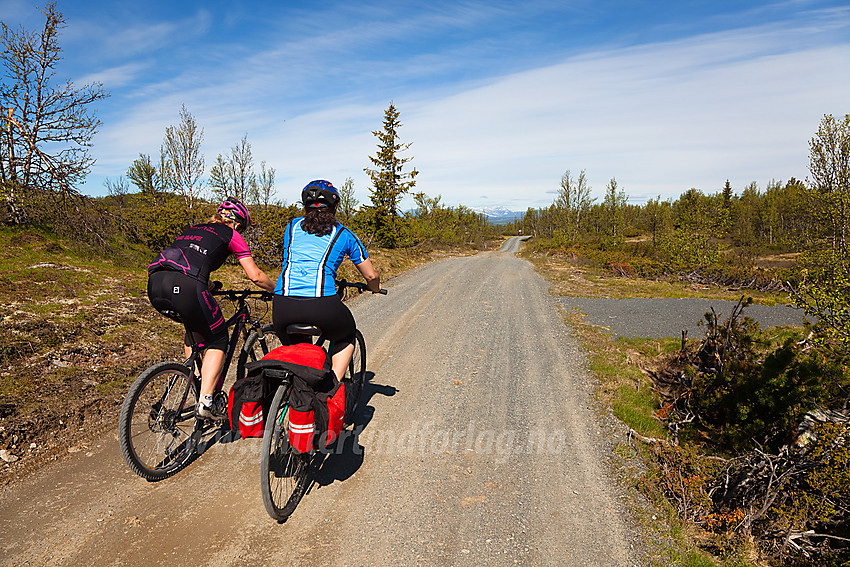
[148,197,274,419]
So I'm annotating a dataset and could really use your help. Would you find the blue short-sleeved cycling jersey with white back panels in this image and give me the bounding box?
[274,217,369,297]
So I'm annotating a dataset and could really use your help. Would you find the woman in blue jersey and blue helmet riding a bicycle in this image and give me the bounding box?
[272,180,381,379]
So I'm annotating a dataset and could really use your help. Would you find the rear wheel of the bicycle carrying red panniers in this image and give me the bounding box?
[260,383,311,522]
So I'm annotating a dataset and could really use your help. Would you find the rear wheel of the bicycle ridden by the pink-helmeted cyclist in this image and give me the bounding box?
[118,362,200,481]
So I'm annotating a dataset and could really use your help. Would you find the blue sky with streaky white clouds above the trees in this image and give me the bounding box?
[0,0,850,210]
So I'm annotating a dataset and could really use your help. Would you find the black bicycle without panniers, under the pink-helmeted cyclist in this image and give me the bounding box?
[118,282,281,481]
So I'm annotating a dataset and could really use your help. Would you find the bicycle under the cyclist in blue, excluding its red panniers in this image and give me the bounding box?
[255,280,380,522]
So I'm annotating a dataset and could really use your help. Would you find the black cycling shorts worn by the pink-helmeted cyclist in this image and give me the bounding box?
[148,270,228,350]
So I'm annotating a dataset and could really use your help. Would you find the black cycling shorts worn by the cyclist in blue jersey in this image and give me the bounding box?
[272,295,357,355]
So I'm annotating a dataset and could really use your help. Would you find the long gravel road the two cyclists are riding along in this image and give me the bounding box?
[0,241,638,567]
